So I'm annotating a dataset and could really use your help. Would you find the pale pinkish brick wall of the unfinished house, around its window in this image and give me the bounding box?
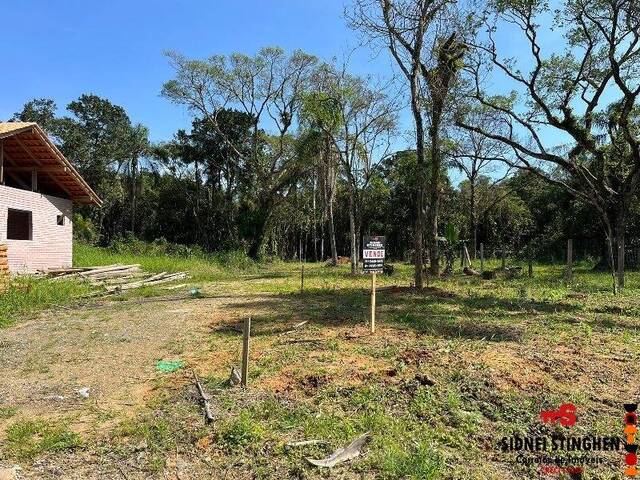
[0,185,73,273]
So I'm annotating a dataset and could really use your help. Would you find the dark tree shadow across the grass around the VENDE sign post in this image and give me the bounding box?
[219,287,581,342]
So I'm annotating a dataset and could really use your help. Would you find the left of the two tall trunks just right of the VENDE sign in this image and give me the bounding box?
[411,74,426,289]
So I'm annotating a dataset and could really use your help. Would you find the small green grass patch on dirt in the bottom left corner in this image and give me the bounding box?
[6,420,82,460]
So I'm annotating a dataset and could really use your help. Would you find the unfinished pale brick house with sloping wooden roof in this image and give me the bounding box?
[0,122,101,273]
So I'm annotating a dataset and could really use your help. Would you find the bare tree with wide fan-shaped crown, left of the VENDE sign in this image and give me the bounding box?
[163,48,317,258]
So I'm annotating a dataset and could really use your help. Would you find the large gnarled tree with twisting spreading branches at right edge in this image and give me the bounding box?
[458,0,640,292]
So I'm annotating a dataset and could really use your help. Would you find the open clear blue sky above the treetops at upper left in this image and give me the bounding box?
[0,0,400,140]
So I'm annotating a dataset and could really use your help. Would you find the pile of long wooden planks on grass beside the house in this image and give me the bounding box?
[43,264,188,293]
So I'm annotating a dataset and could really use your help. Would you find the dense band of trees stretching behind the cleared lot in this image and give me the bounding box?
[8,0,640,286]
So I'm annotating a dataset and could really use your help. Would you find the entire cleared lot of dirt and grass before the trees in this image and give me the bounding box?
[0,264,640,479]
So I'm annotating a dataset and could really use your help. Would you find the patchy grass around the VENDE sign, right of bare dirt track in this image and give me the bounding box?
[5,255,640,480]
